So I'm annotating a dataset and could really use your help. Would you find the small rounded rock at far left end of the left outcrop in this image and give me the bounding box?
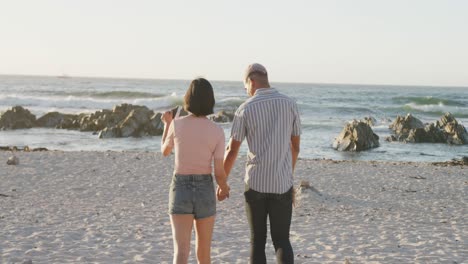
[0,106,36,130]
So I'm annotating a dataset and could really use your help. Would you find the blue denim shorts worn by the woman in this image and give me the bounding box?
[169,174,216,219]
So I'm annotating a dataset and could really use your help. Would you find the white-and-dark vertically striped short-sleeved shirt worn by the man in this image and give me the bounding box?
[231,88,301,194]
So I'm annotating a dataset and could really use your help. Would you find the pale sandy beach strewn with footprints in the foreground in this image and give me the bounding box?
[0,151,468,264]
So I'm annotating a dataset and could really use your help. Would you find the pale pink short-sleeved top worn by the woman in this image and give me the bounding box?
[164,115,225,174]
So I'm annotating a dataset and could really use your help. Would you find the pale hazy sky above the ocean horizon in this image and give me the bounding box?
[0,0,468,86]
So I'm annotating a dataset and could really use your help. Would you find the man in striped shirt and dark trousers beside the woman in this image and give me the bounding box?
[224,63,301,264]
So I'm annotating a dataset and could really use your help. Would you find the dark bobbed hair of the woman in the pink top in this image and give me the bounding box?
[184,78,215,116]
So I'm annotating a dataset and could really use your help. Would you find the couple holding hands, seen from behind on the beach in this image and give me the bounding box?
[161,63,301,264]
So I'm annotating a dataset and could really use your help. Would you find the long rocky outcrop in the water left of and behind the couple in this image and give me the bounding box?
[0,104,234,138]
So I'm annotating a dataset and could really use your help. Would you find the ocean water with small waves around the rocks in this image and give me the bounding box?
[0,75,468,162]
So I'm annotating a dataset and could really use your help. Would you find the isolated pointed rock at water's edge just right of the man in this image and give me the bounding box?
[333,120,379,151]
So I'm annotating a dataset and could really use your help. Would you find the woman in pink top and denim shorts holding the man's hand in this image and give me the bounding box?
[161,78,229,264]
